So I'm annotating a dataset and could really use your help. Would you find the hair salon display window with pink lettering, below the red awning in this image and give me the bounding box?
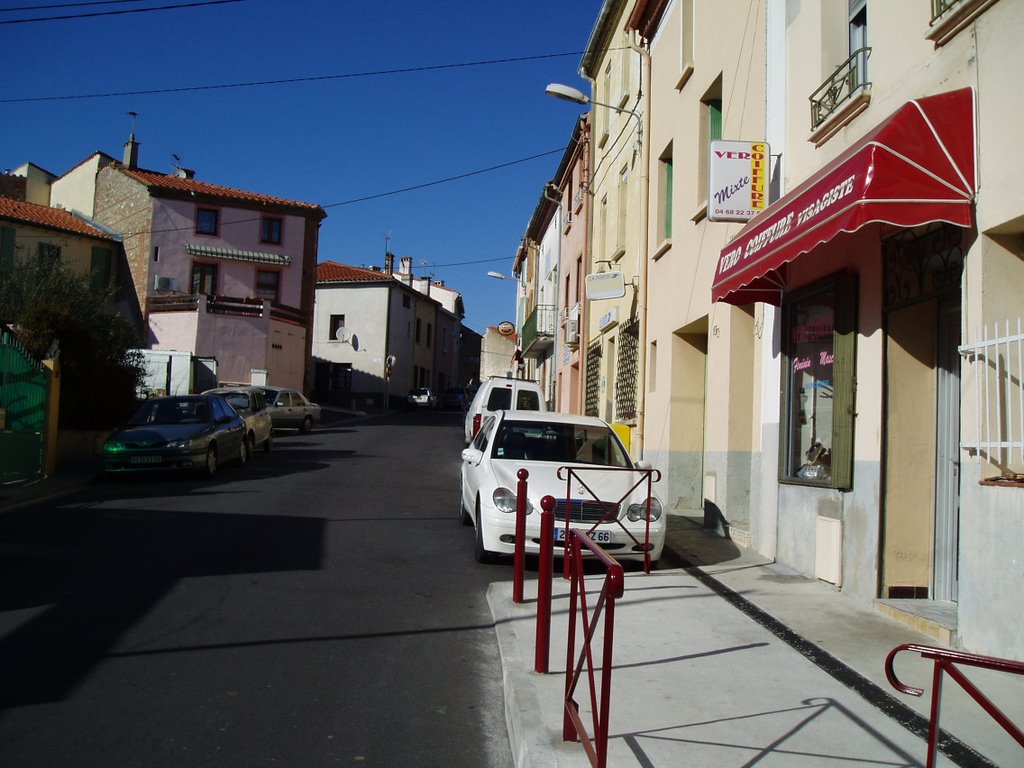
[779,274,856,488]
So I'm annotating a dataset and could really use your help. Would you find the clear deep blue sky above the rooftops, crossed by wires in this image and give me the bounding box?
[0,0,601,333]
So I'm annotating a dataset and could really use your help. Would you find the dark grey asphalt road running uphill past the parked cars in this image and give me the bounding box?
[0,413,511,768]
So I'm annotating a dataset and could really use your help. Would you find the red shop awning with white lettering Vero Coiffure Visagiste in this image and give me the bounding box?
[711,88,977,304]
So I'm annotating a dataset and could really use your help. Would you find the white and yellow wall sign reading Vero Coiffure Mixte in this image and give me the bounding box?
[708,141,771,221]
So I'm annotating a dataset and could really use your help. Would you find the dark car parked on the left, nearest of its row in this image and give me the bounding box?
[103,394,249,477]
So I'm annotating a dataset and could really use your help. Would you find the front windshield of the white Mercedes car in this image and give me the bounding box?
[493,421,633,467]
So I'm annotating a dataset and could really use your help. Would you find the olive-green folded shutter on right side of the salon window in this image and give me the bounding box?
[831,273,857,489]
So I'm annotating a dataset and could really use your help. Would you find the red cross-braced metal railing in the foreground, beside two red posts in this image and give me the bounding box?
[562,528,626,768]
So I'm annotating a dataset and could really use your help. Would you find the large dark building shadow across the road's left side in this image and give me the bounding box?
[0,507,326,709]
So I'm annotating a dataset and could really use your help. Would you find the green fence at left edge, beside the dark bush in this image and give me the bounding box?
[0,329,48,482]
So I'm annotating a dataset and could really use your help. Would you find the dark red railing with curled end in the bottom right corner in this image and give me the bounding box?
[886,643,1024,768]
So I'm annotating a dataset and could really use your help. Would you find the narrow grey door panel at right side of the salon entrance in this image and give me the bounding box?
[931,300,961,602]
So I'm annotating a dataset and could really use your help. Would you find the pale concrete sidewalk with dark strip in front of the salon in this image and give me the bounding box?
[487,515,1024,768]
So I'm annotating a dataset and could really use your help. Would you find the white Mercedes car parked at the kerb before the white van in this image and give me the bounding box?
[461,411,666,567]
